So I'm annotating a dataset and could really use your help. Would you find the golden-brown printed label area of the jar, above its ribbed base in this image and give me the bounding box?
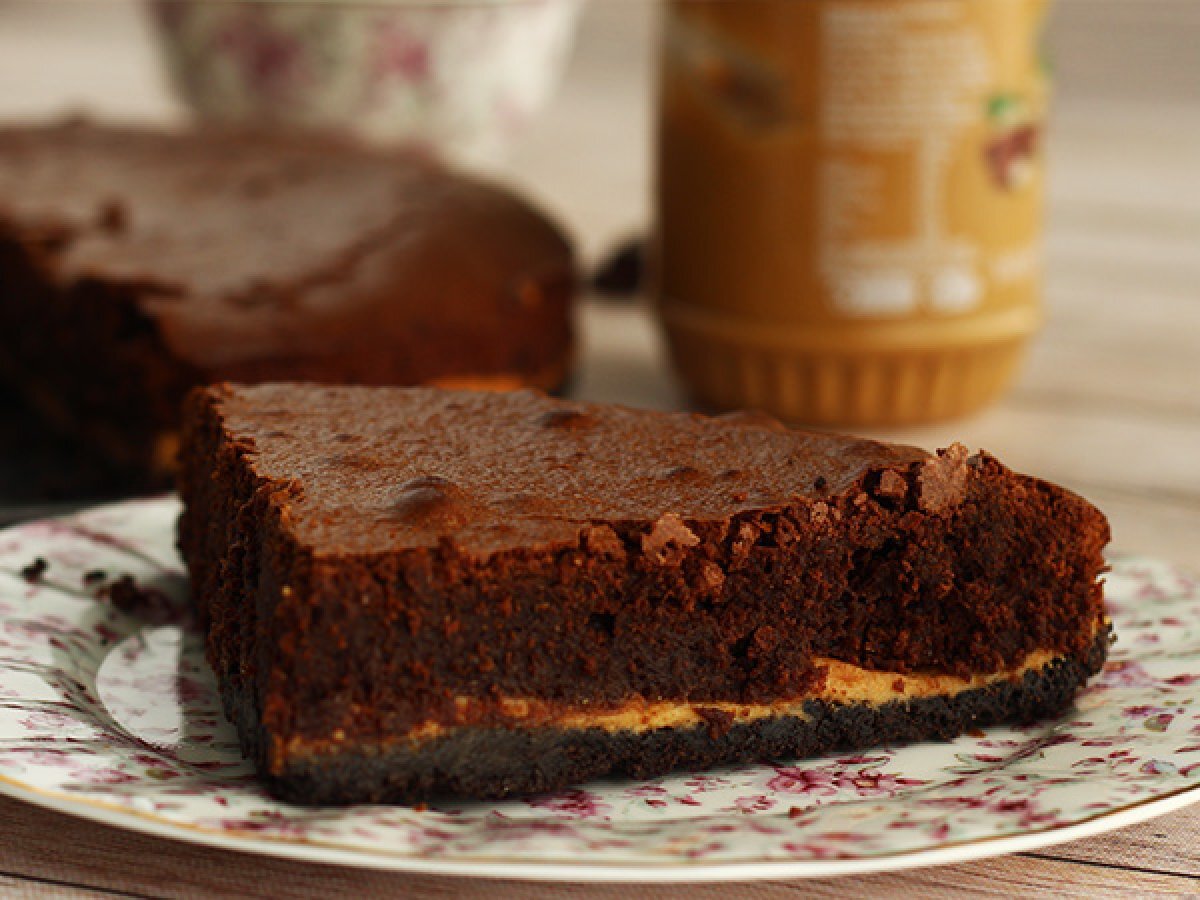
[658,0,1046,328]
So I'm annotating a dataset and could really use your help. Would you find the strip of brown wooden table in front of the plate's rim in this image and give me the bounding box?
[0,798,1200,900]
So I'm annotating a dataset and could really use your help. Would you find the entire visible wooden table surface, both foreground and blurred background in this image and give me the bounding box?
[0,0,1200,900]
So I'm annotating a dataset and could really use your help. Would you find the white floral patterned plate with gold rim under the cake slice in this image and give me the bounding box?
[0,498,1200,881]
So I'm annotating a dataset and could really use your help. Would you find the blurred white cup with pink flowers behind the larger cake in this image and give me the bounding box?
[150,0,582,162]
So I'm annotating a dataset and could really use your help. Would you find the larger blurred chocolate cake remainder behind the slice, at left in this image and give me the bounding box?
[0,124,576,481]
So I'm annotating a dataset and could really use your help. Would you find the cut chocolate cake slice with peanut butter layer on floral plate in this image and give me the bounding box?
[180,384,1109,804]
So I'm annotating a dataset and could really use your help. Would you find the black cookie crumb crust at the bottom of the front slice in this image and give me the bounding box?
[238,629,1110,805]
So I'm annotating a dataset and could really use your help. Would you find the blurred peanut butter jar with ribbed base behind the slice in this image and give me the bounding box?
[655,0,1048,426]
